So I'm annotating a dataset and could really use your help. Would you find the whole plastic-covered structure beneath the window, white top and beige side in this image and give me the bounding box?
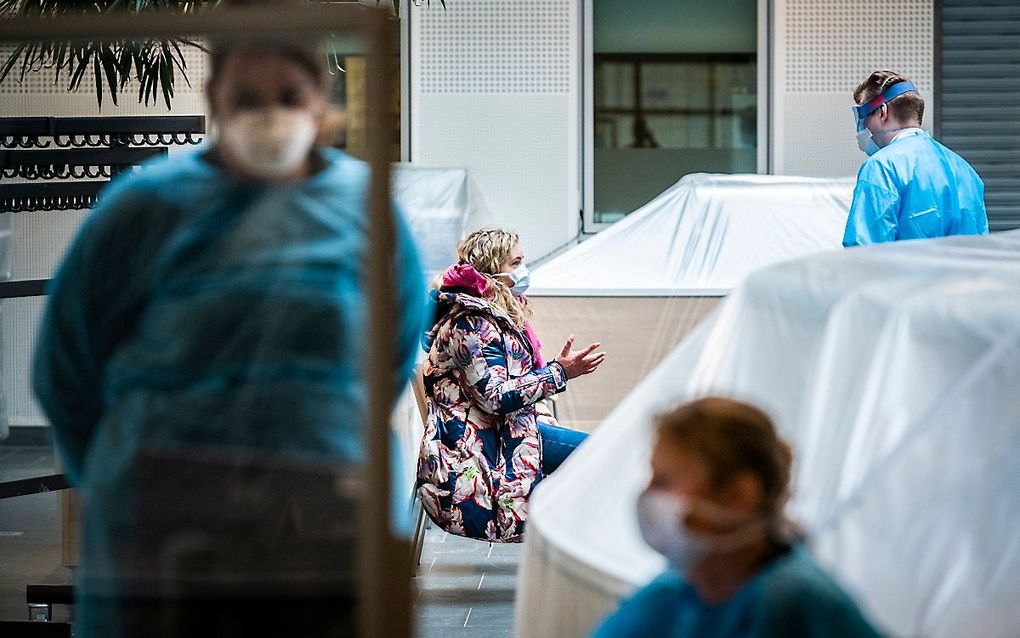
[528,174,854,430]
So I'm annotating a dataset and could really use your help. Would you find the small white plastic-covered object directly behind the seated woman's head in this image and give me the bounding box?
[393,163,493,281]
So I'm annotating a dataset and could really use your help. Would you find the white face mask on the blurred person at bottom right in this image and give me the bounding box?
[638,490,766,573]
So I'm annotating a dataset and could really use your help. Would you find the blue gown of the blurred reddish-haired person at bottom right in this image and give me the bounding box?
[595,545,879,638]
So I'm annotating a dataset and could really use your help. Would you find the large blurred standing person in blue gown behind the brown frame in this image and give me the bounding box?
[34,35,425,636]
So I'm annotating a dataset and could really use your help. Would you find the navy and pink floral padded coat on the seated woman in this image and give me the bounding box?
[417,289,566,542]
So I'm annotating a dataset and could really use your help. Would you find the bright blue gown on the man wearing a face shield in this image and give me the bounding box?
[843,130,988,247]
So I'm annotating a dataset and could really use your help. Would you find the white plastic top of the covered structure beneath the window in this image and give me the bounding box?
[528,173,854,296]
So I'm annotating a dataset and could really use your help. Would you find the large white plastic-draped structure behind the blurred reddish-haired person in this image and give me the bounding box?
[516,231,1020,637]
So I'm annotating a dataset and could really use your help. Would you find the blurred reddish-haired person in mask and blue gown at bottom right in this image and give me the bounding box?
[596,398,878,638]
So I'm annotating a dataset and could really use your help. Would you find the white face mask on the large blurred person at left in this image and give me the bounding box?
[219,106,317,180]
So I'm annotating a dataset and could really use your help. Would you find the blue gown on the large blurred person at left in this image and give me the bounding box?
[34,150,426,636]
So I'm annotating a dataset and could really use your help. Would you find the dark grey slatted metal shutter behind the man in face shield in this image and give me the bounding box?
[935,0,1020,231]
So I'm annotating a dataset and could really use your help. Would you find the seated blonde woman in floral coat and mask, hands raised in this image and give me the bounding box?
[417,229,605,542]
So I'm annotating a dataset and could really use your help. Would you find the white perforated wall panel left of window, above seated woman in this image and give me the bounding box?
[405,0,580,260]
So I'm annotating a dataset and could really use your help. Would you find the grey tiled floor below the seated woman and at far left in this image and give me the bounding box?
[0,445,521,638]
